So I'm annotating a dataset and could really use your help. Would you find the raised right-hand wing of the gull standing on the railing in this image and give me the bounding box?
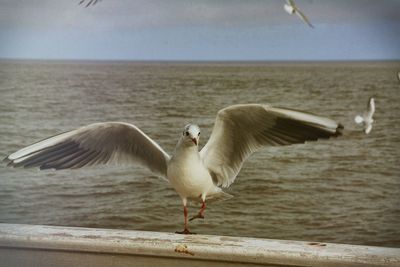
[200,104,343,187]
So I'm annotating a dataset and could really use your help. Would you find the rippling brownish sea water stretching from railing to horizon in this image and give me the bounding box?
[0,60,400,247]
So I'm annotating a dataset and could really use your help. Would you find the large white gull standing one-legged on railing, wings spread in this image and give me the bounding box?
[4,104,343,234]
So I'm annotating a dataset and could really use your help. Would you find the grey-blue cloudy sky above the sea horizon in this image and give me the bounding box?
[0,0,400,61]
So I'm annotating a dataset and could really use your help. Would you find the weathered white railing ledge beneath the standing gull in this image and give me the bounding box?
[0,224,400,267]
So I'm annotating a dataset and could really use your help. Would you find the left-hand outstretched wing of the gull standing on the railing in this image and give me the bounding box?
[5,122,169,177]
